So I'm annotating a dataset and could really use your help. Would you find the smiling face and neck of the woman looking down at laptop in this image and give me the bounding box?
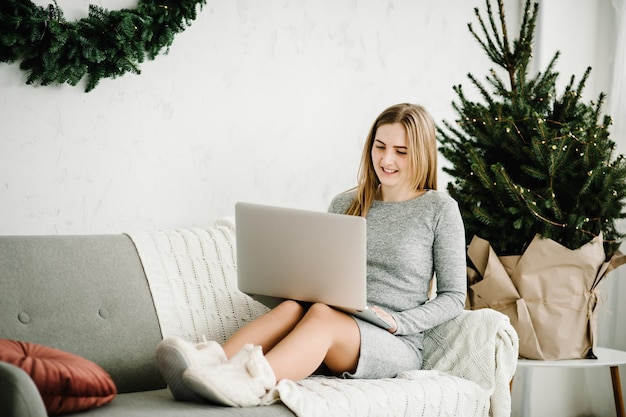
[371,123,416,201]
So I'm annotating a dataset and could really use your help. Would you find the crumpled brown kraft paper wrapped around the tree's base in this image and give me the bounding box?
[467,232,626,360]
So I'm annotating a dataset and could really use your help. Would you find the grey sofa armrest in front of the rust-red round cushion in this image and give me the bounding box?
[0,361,48,417]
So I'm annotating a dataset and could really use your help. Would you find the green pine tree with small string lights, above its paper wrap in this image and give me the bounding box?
[438,0,626,258]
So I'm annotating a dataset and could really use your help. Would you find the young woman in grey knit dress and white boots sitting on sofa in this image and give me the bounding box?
[157,104,466,406]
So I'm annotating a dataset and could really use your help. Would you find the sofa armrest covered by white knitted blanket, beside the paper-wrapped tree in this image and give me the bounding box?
[423,308,519,416]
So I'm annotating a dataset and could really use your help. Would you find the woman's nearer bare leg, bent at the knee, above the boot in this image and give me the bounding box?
[265,304,361,380]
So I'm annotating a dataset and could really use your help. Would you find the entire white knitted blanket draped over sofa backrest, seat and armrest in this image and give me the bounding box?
[129,223,518,417]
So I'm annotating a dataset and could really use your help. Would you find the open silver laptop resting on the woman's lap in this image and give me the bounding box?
[235,202,391,329]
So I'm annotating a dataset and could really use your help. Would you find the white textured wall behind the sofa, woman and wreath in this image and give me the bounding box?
[0,0,498,234]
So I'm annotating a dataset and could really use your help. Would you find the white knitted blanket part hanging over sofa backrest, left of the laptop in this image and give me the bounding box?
[128,218,267,343]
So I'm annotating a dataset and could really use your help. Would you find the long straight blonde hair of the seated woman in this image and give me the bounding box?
[346,103,437,217]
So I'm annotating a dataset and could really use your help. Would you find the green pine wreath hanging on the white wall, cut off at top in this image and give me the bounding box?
[0,0,206,91]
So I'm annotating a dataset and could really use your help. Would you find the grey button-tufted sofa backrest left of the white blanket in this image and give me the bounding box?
[0,234,166,394]
